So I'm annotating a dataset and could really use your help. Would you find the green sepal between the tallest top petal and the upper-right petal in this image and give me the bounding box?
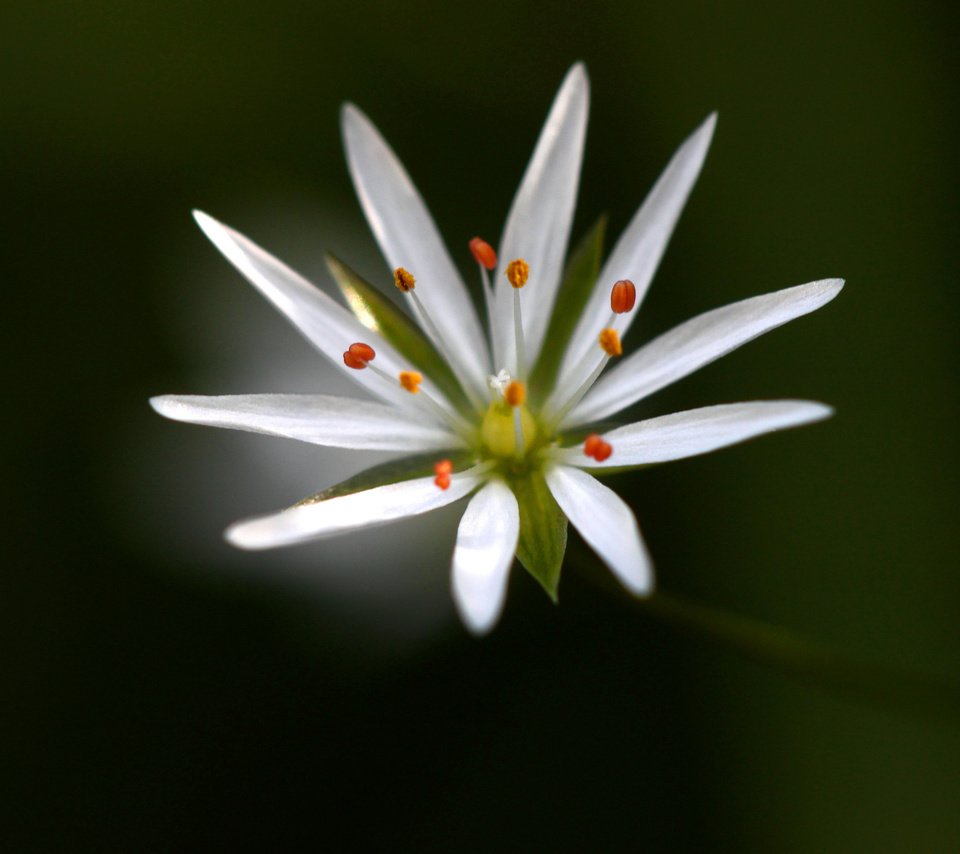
[530,216,607,403]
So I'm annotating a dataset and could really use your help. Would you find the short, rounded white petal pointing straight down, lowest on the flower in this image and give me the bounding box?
[452,480,520,634]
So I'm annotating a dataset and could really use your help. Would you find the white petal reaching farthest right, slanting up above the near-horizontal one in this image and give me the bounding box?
[564,279,843,427]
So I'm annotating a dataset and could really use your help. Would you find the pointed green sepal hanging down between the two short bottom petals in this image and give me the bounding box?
[510,474,567,602]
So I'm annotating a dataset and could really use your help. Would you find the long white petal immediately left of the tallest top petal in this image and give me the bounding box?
[341,104,490,397]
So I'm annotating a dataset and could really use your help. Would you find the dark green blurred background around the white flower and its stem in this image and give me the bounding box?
[0,0,960,852]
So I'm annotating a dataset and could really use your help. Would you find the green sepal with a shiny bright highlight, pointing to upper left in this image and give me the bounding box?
[325,252,471,412]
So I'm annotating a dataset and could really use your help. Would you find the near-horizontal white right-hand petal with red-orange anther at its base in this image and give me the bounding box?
[558,400,833,469]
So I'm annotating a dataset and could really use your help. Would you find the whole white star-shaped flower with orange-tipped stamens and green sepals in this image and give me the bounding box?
[151,64,843,632]
